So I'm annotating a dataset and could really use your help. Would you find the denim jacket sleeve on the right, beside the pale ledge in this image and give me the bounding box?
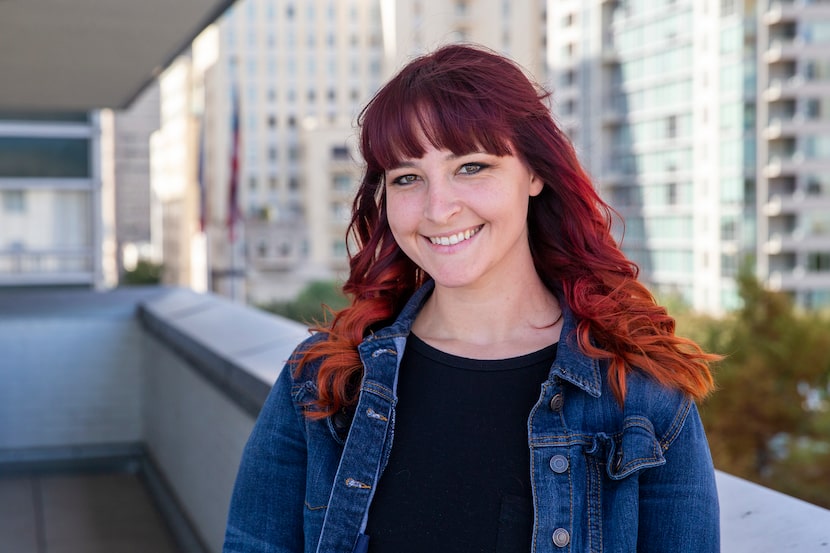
[637,403,720,553]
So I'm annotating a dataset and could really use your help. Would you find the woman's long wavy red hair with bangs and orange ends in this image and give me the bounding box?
[298,45,719,418]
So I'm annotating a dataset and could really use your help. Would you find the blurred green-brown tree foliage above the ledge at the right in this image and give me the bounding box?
[678,271,830,507]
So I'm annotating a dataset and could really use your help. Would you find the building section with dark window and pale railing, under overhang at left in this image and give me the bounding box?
[0,112,117,288]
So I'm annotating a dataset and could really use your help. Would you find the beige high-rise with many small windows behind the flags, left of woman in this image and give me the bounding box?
[185,0,383,302]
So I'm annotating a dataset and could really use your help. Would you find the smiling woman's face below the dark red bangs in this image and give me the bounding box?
[385,142,543,290]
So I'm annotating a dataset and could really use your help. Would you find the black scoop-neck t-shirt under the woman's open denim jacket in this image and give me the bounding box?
[366,335,556,553]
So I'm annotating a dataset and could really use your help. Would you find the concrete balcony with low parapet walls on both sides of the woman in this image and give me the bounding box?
[0,288,830,553]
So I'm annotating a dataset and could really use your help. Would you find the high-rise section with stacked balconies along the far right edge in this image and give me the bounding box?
[757,0,830,308]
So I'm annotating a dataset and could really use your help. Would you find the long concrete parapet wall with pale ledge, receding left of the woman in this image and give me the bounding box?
[141,290,308,552]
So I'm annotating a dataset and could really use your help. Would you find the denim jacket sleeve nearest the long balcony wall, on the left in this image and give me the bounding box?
[223,366,307,553]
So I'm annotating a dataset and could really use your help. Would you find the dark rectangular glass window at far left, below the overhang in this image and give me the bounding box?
[0,136,91,178]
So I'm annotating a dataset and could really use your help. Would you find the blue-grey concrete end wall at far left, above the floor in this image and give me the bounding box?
[0,286,147,450]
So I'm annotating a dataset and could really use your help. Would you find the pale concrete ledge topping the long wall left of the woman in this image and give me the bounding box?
[139,289,308,417]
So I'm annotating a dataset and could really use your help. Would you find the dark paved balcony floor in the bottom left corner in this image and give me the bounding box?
[0,473,178,553]
